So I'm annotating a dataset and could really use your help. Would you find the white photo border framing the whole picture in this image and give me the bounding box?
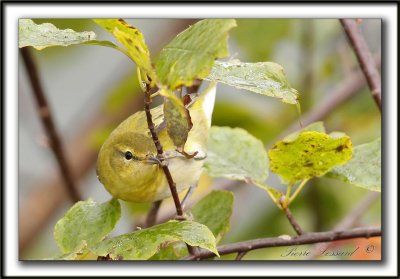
[2,2,398,277]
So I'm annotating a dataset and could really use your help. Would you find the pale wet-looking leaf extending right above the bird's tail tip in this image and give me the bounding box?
[206,60,299,104]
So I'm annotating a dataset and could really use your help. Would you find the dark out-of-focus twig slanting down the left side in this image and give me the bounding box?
[21,47,81,202]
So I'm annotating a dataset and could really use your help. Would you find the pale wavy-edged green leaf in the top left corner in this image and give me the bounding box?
[18,19,96,50]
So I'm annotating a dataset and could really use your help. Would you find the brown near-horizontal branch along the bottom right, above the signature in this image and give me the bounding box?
[184,227,382,260]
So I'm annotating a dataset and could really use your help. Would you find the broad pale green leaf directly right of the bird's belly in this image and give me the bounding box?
[205,126,268,184]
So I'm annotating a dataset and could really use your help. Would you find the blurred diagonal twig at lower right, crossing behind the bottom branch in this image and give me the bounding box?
[308,192,380,259]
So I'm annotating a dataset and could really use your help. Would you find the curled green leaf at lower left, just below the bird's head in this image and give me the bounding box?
[54,199,121,253]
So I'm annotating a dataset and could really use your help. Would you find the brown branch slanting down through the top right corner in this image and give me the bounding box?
[340,19,382,110]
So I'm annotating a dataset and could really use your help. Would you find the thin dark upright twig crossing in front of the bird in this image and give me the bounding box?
[144,85,183,217]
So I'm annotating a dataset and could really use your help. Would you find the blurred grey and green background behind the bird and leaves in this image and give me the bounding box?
[18,19,381,260]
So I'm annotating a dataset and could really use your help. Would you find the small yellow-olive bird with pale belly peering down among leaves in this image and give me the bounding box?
[96,83,216,202]
